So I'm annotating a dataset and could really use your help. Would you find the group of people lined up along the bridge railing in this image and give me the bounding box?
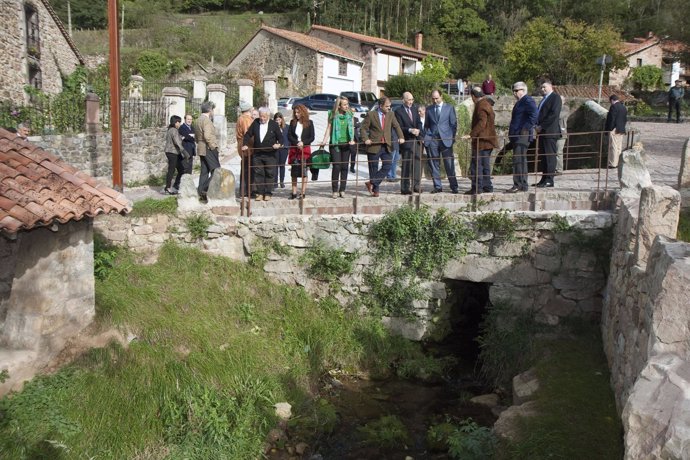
[164,75,644,201]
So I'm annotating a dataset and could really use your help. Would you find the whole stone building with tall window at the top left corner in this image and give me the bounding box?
[0,0,84,105]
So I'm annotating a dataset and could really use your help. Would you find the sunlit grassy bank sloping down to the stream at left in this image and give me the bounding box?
[0,243,421,459]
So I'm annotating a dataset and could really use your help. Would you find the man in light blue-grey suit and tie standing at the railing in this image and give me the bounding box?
[424,90,458,193]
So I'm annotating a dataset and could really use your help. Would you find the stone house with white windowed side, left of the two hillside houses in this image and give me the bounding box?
[227,25,364,97]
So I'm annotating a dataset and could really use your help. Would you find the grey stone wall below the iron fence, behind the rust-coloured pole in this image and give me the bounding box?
[31,123,237,184]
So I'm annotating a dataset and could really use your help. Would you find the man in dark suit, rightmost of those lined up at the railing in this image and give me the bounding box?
[535,79,561,188]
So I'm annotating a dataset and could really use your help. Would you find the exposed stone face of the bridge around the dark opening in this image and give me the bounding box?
[96,211,612,340]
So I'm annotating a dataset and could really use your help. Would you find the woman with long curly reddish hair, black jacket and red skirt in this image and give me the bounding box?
[288,104,315,200]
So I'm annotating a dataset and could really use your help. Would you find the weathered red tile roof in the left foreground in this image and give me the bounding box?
[0,128,131,237]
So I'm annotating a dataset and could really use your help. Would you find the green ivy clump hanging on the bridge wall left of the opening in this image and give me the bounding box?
[364,206,474,316]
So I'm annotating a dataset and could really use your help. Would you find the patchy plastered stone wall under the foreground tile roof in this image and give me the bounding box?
[0,219,95,394]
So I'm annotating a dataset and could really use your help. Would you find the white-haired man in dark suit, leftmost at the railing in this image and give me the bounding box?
[242,107,283,201]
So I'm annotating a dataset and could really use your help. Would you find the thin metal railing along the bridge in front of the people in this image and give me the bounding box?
[232,131,634,215]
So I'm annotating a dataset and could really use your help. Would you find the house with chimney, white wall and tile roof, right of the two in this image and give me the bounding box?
[309,25,448,96]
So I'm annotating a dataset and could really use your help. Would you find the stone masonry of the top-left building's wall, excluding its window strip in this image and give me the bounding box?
[0,0,79,105]
